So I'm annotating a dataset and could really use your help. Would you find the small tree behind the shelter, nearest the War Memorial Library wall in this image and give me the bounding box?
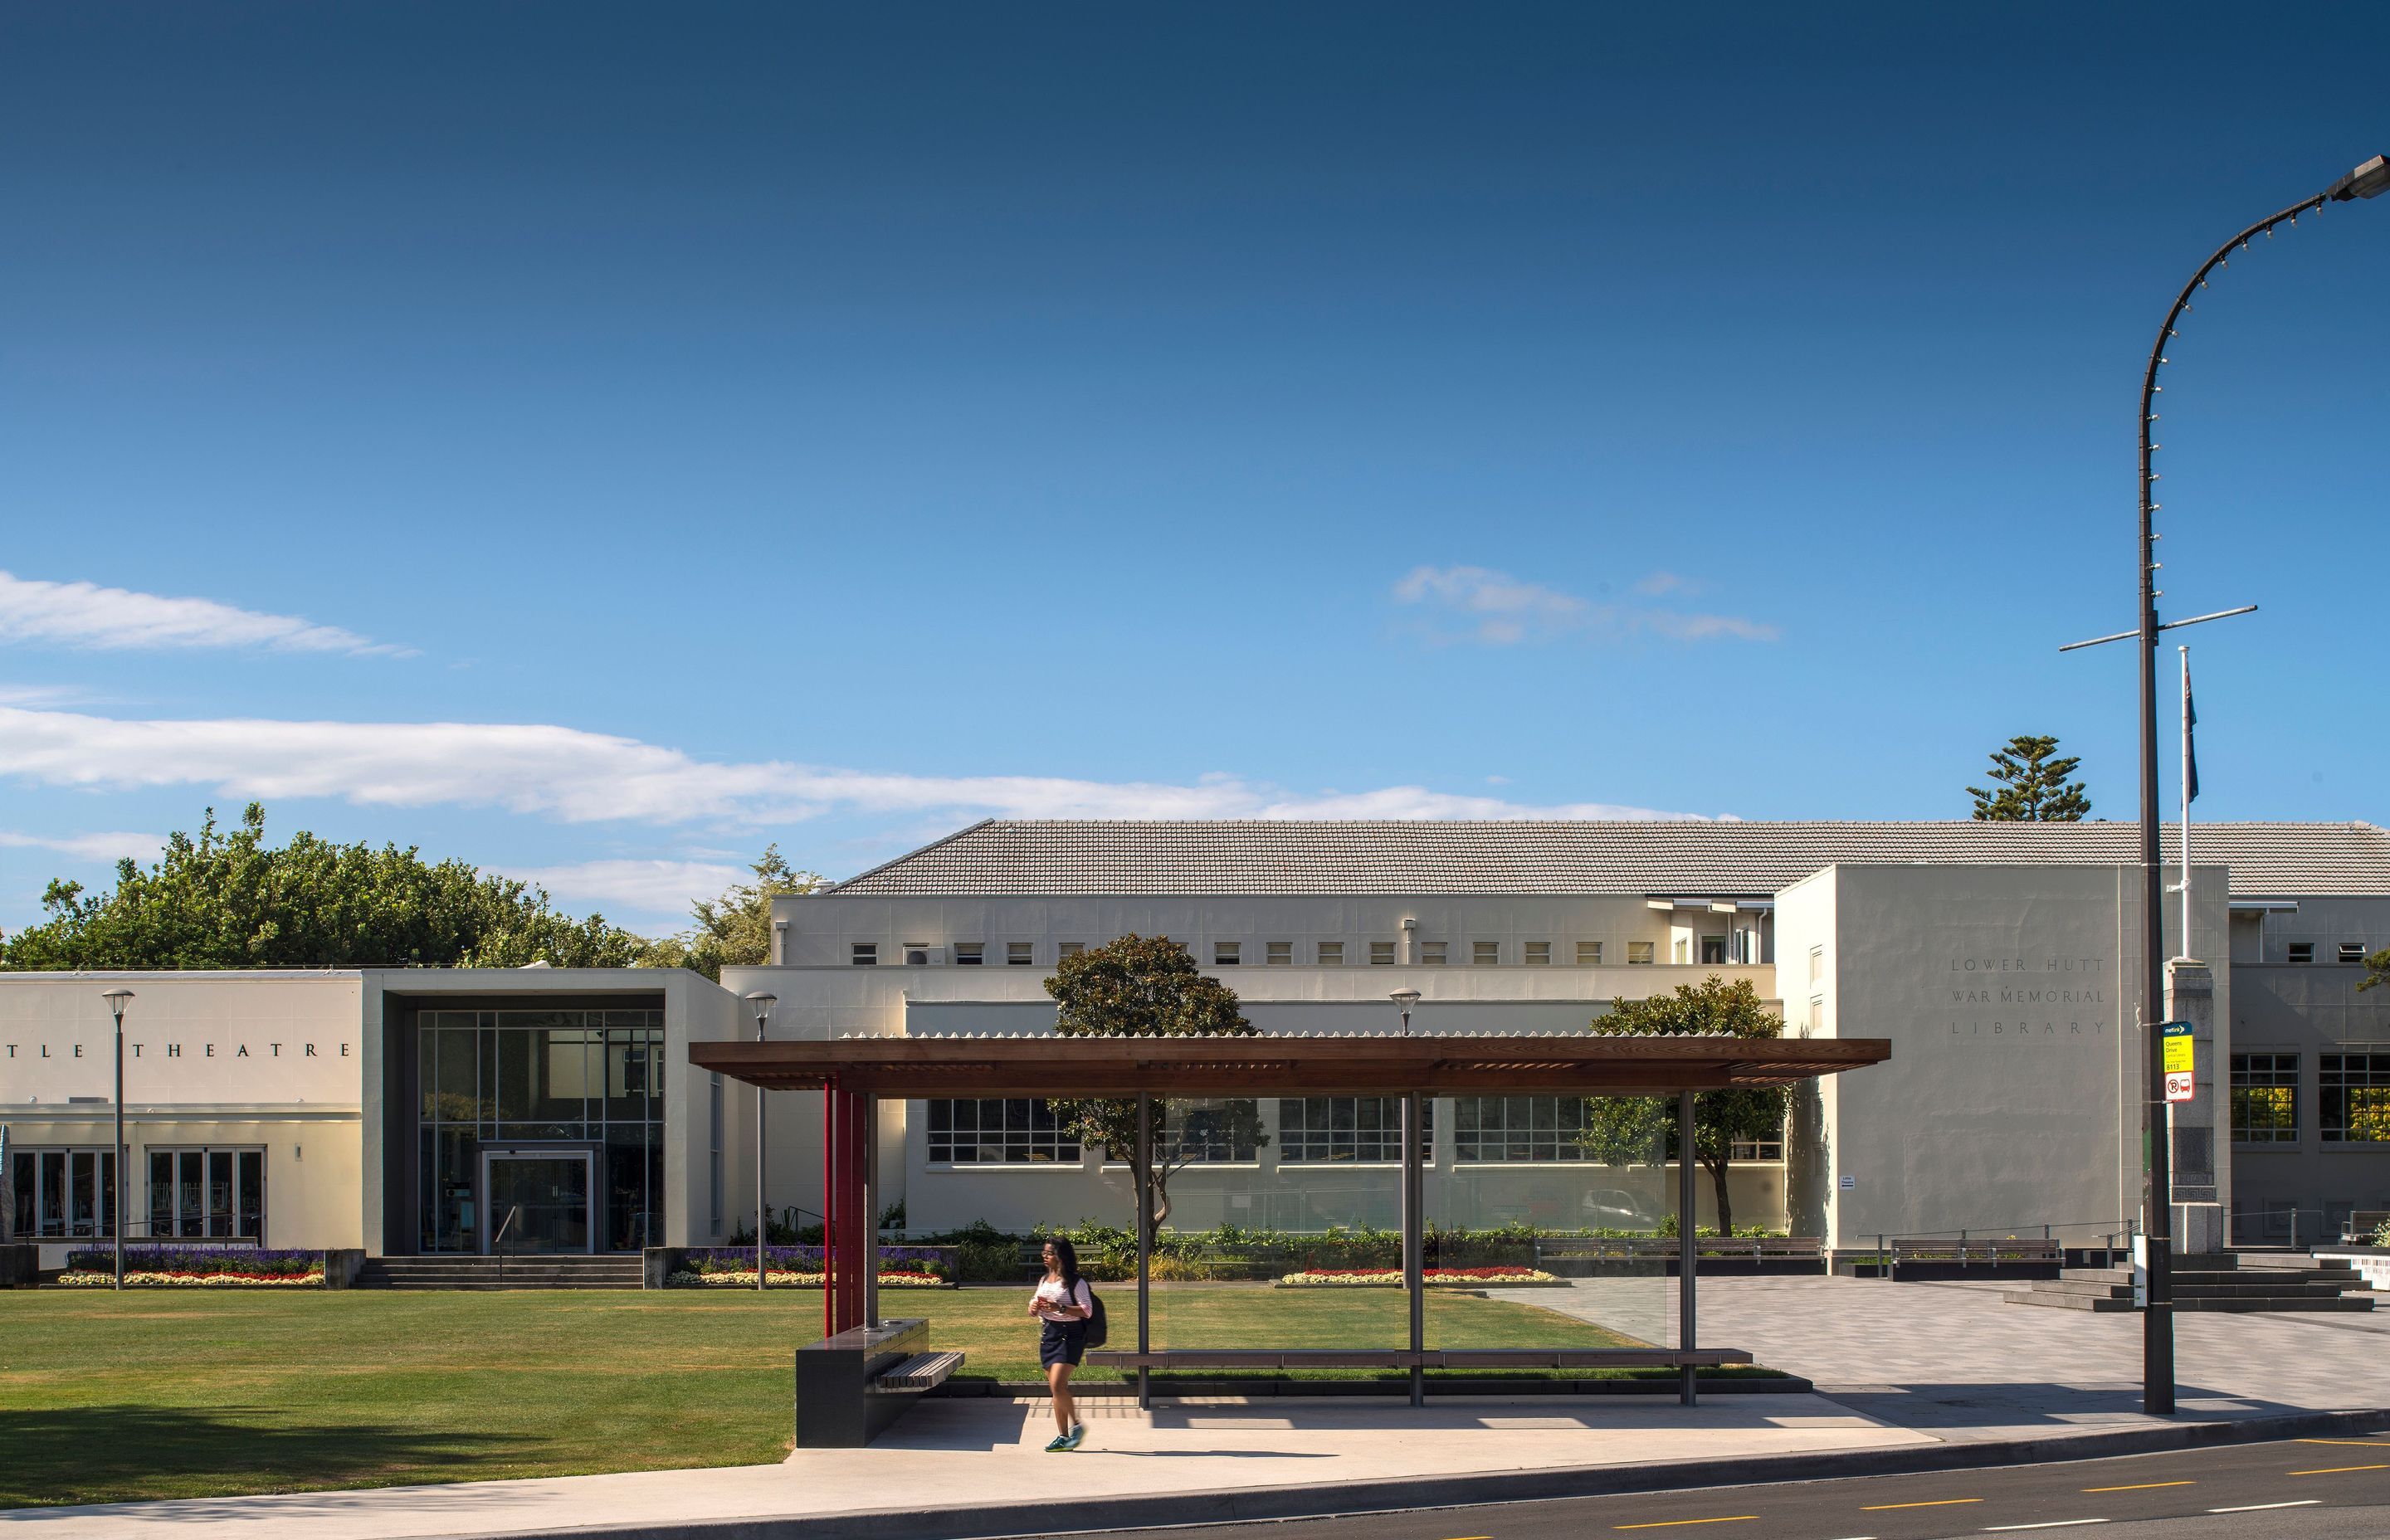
[1580,973,1790,1234]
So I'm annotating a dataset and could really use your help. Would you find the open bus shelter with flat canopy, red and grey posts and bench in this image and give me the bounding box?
[688,1033,1890,1406]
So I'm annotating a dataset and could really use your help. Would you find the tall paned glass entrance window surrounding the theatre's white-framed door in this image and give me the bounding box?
[416,1009,665,1250]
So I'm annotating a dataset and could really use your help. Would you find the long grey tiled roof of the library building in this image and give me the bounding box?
[834,818,2390,897]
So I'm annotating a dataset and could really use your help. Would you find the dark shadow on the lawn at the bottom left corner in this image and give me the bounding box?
[0,1406,542,1509]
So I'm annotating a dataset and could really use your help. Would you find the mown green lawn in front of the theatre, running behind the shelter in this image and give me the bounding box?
[0,1284,1653,1507]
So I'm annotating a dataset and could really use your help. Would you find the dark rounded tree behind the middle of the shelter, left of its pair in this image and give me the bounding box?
[1046,935,1269,1244]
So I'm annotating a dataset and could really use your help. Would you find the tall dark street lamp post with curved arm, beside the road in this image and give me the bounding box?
[2139,155,2390,1416]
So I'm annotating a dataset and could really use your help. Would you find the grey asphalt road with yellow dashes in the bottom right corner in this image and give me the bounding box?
[1061,1435,2390,1540]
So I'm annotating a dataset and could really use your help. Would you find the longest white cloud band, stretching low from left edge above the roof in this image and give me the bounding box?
[0,708,1720,825]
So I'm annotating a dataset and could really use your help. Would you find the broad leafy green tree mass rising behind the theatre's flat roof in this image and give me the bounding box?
[0,803,650,968]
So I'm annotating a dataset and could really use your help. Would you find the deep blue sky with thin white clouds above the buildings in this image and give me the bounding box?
[0,5,2390,930]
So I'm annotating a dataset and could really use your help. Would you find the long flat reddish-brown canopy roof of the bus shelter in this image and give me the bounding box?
[688,1033,1893,1098]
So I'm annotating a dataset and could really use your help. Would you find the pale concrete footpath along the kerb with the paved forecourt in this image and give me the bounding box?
[0,1279,2390,1540]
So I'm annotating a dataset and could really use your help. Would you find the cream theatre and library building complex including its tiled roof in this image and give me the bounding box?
[0,821,2390,1265]
